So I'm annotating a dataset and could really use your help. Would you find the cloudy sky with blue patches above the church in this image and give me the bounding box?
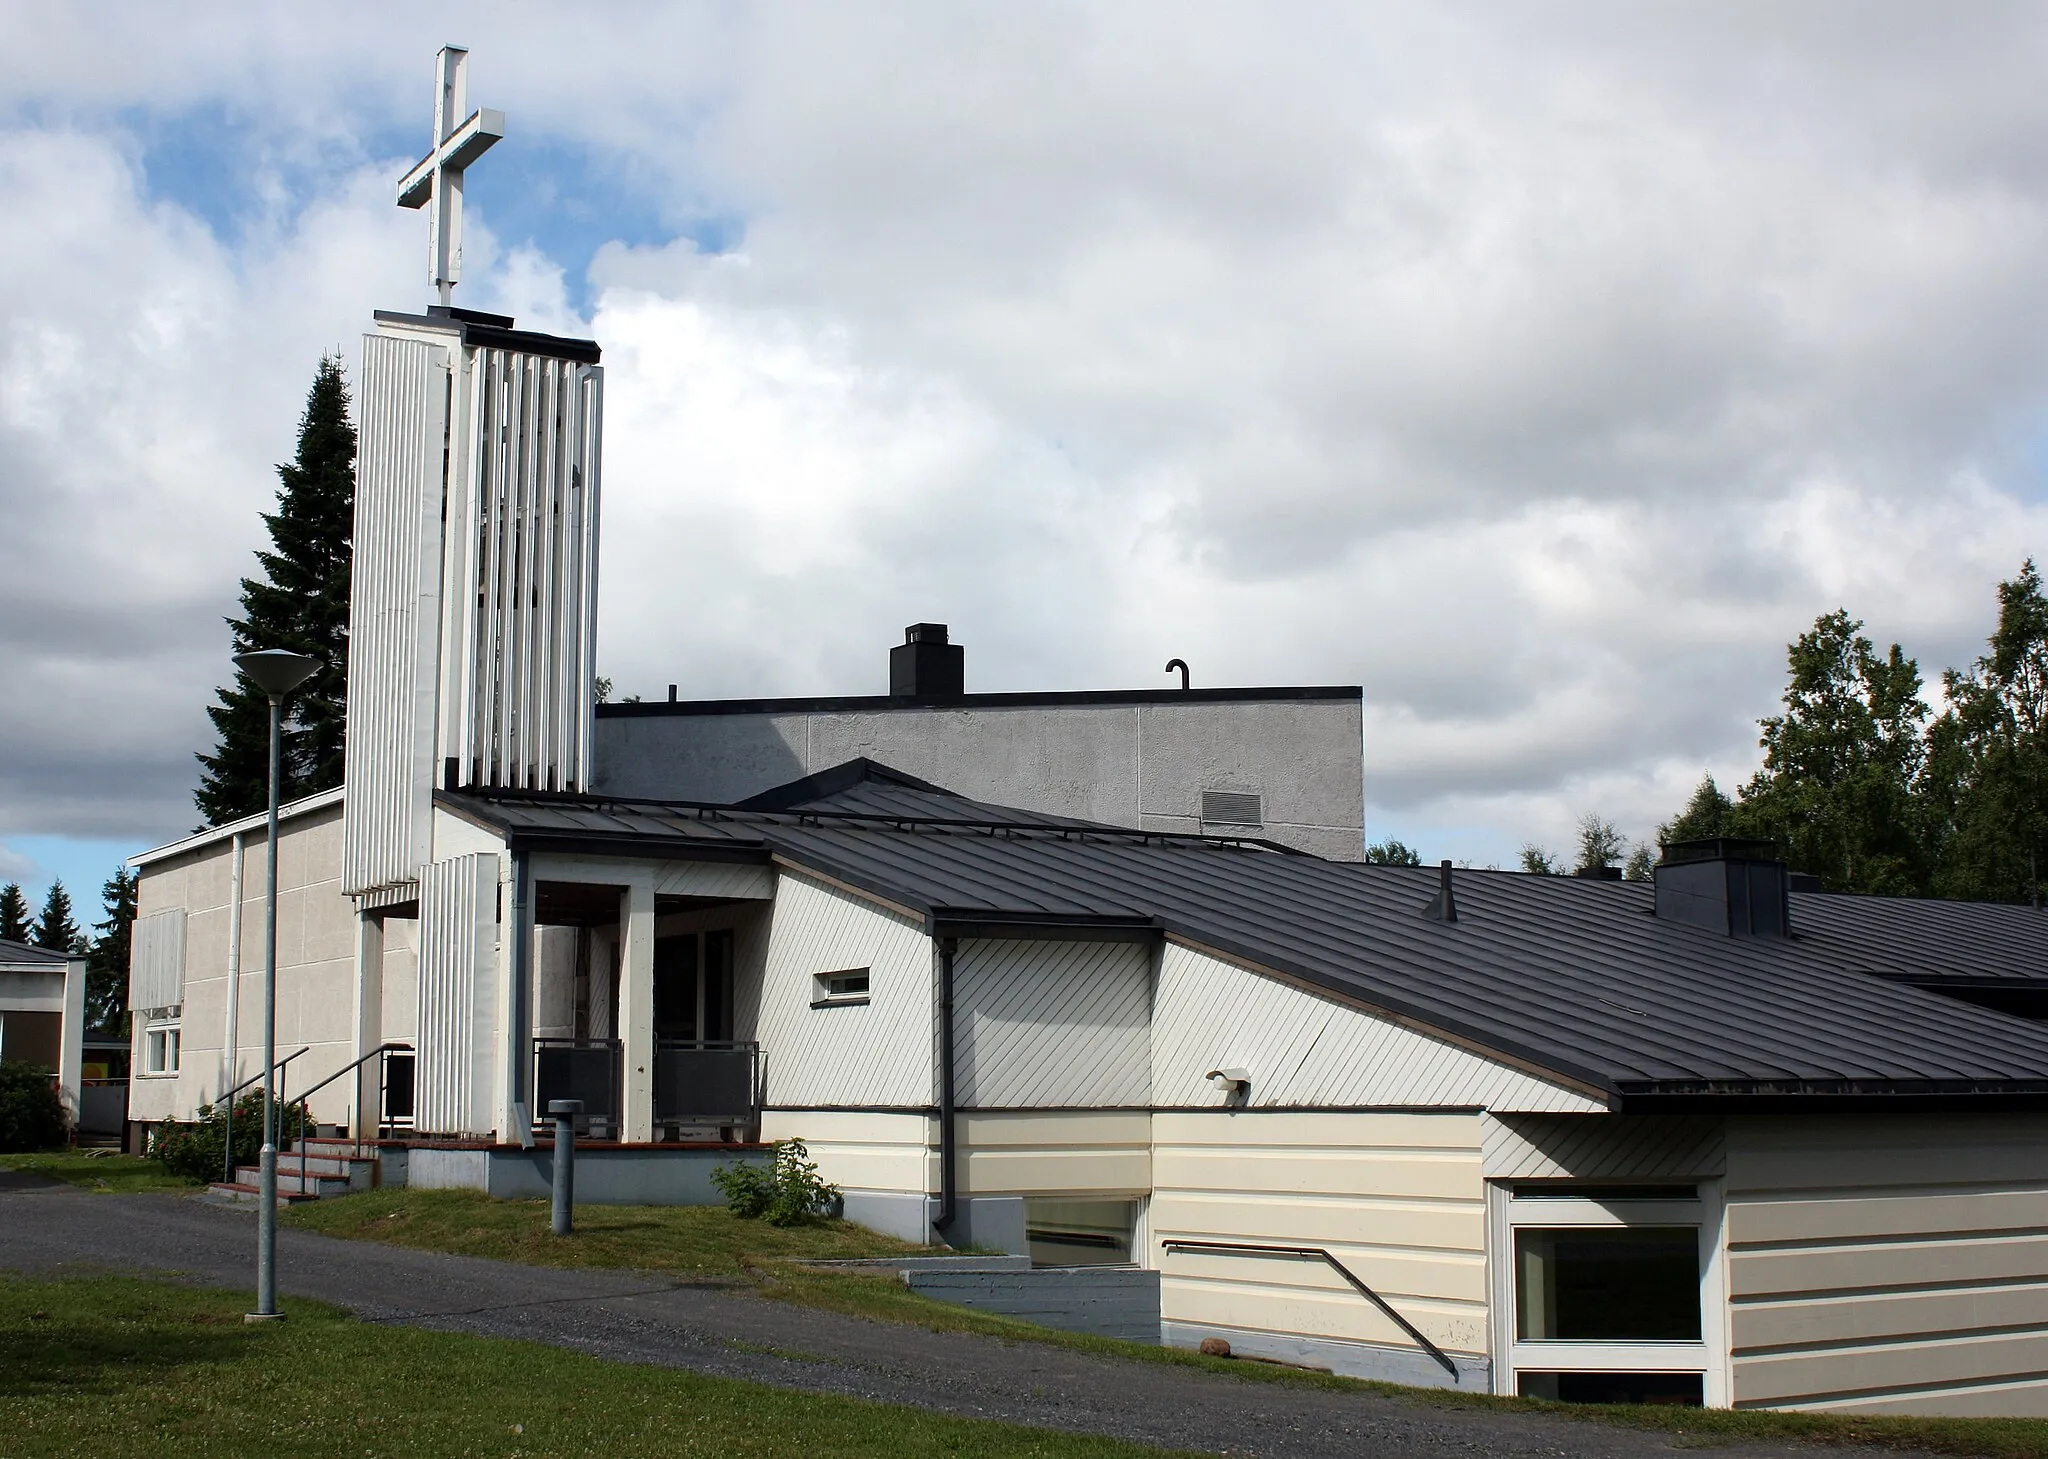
[0,0,2048,893]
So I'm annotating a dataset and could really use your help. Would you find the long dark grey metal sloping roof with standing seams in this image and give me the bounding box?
[448,781,2048,1107]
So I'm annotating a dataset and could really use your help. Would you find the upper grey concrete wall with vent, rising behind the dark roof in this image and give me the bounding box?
[596,699,1366,861]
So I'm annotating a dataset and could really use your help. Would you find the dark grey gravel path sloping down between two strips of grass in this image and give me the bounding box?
[0,1172,1931,1459]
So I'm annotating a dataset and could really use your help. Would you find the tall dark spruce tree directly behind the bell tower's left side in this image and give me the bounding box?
[193,355,356,826]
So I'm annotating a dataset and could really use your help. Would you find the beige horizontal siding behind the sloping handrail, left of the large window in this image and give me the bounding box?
[1149,1113,1487,1354]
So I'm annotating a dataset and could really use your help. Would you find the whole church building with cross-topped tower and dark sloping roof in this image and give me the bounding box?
[119,53,2048,1414]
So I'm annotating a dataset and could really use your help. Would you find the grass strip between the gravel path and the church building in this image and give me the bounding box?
[283,1191,2048,1459]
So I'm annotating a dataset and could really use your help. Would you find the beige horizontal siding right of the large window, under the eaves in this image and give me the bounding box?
[1726,1115,2048,1416]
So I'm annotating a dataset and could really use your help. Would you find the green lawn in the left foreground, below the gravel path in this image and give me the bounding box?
[0,1277,1187,1459]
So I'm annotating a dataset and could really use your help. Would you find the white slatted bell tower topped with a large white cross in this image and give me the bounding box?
[342,47,604,902]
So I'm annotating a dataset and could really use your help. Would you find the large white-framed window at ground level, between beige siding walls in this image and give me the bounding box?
[1489,1180,1729,1408]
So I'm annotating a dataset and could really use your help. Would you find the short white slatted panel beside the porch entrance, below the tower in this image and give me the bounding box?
[414,852,500,1135]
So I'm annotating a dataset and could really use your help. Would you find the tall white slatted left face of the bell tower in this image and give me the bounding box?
[342,334,449,893]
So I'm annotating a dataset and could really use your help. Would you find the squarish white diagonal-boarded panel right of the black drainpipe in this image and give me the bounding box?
[952,939,1151,1109]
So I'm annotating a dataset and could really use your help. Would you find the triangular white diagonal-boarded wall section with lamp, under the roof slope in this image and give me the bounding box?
[1153,943,1606,1113]
